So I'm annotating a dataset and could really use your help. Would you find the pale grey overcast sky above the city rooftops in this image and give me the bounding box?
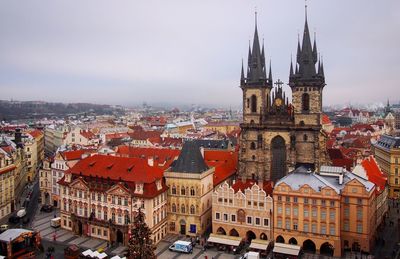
[0,0,400,107]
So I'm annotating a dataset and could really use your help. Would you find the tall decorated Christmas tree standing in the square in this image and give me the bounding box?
[128,209,156,259]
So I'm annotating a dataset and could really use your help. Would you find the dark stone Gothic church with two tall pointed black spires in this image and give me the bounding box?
[238,8,326,182]
